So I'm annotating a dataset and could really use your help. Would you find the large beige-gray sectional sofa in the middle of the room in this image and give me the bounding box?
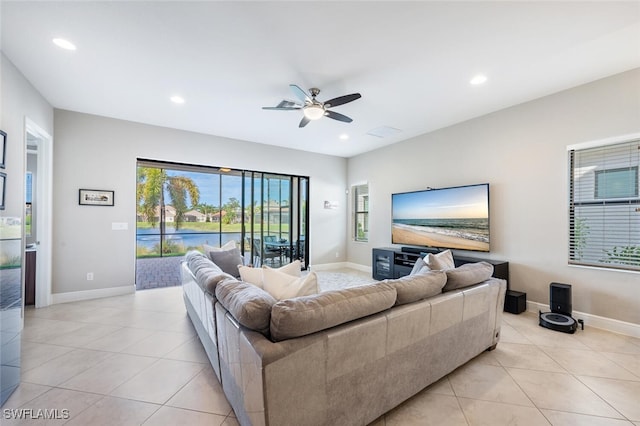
[181,252,506,426]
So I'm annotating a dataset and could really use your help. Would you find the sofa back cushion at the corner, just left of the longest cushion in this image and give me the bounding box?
[216,279,276,335]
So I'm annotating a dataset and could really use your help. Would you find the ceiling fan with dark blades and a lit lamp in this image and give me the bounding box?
[262,84,361,127]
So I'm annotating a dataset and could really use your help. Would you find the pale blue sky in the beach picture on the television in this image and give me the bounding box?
[392,184,489,219]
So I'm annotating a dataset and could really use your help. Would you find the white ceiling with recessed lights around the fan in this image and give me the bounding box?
[0,1,640,157]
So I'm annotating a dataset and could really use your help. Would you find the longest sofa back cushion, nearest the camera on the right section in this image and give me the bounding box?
[271,283,397,341]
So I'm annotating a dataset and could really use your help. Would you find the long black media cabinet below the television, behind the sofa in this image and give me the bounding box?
[371,248,509,290]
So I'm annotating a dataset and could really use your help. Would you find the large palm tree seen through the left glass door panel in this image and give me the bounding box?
[136,167,200,233]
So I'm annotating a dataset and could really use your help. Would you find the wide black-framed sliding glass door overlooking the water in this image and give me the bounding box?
[136,160,309,288]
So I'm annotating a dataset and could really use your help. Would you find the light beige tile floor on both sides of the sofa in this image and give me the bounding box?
[0,280,640,426]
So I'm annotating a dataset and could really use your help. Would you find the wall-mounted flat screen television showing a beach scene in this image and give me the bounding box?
[391,183,489,252]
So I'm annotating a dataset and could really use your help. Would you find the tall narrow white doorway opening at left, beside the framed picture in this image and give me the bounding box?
[23,118,53,308]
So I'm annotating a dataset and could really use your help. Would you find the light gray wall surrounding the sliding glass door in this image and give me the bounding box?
[53,110,347,294]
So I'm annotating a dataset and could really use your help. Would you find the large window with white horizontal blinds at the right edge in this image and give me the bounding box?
[569,136,640,271]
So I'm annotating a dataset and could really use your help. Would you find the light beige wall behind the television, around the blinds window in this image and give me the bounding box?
[348,69,640,324]
